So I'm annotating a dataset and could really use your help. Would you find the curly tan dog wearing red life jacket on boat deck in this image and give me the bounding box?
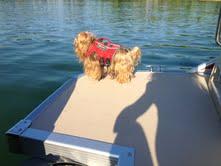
[73,32,141,84]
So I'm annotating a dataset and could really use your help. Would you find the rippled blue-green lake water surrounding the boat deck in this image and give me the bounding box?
[0,0,221,165]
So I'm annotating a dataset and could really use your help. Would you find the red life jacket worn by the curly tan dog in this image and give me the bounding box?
[86,38,120,65]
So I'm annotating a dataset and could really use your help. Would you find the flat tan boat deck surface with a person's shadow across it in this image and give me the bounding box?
[32,72,221,166]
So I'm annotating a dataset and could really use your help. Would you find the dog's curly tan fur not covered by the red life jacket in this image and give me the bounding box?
[73,32,141,83]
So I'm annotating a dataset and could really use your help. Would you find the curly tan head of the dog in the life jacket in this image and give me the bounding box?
[73,32,96,62]
